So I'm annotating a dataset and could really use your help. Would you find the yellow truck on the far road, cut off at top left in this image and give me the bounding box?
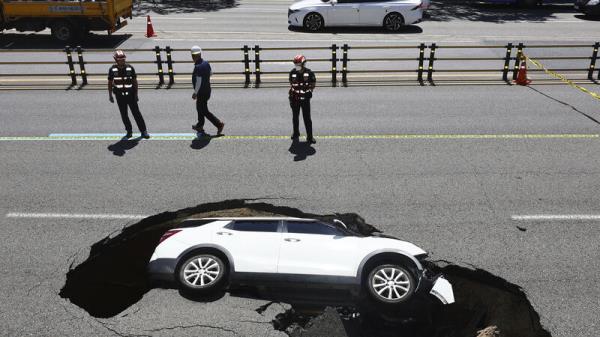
[0,0,133,42]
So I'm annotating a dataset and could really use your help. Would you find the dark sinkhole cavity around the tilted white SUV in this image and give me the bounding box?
[60,200,550,337]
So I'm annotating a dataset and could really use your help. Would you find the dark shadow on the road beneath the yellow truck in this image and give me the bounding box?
[0,32,131,50]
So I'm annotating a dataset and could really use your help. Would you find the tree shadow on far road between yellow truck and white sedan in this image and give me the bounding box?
[133,0,239,15]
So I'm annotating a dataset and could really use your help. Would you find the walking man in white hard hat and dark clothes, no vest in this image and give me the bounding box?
[191,46,225,135]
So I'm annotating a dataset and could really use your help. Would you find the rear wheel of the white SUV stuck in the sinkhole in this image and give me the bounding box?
[176,253,227,293]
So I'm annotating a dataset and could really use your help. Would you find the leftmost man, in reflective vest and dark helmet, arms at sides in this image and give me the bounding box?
[108,50,150,139]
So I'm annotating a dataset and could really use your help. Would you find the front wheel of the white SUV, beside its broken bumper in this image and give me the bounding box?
[366,264,416,305]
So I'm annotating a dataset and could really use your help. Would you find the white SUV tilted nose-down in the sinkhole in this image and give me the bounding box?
[148,217,454,305]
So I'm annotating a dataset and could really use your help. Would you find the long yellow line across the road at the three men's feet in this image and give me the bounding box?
[0,133,600,141]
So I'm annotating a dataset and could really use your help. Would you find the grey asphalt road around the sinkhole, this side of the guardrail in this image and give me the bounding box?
[0,86,600,337]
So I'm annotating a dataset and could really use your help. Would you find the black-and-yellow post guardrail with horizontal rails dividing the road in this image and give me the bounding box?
[0,42,600,88]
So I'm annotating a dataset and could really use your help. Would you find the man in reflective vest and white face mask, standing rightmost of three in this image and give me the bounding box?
[289,55,317,144]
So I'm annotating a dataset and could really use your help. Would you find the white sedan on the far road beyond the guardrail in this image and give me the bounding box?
[288,0,429,31]
